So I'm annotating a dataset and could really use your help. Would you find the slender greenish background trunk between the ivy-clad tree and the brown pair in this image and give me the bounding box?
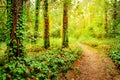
[34,0,41,42]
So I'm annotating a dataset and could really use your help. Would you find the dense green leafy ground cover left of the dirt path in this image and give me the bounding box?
[0,48,81,80]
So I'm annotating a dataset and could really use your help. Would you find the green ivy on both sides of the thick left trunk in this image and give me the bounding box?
[6,0,26,57]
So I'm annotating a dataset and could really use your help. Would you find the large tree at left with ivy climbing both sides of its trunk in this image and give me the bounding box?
[7,0,24,57]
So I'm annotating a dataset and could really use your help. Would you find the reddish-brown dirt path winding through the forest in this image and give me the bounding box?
[61,44,120,80]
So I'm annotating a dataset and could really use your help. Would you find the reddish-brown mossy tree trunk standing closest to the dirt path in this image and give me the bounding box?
[62,1,68,48]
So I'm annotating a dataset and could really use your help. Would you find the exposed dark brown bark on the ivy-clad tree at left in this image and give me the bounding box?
[10,0,23,57]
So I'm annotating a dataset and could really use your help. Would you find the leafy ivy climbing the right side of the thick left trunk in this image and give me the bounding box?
[16,2,26,56]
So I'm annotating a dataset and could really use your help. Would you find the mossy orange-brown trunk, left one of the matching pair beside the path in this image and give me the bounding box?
[44,0,50,49]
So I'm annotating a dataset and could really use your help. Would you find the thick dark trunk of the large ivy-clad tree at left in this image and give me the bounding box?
[7,0,23,57]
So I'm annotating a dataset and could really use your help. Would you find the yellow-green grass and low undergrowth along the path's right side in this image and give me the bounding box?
[80,37,120,68]
